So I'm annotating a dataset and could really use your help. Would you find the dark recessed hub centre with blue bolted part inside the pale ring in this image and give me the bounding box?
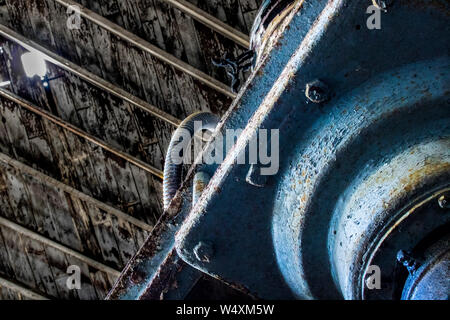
[360,189,450,299]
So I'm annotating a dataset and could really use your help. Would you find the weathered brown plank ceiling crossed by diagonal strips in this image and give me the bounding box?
[0,0,261,299]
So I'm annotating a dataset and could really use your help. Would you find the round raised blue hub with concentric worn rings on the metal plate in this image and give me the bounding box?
[273,58,450,300]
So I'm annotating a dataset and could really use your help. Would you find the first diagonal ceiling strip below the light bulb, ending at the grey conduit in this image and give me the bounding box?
[0,88,164,179]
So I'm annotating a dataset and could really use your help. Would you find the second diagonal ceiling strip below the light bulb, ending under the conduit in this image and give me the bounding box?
[0,152,153,232]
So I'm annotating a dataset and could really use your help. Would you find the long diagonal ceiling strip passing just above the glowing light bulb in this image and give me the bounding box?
[0,24,181,126]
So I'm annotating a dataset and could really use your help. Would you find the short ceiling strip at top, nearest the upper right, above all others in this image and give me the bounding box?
[164,0,250,49]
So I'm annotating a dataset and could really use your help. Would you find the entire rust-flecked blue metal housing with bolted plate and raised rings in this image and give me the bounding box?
[110,0,450,299]
